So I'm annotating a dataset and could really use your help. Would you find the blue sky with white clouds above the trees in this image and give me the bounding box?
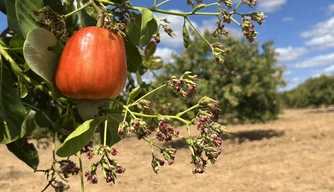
[0,0,334,89]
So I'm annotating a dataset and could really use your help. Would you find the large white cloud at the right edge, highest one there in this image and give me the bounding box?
[300,17,334,49]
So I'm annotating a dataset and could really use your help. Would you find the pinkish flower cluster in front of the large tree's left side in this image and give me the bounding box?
[167,71,197,99]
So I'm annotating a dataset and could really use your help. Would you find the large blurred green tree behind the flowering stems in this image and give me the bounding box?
[159,31,285,122]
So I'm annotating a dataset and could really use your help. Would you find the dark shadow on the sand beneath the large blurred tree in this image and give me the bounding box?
[168,129,284,149]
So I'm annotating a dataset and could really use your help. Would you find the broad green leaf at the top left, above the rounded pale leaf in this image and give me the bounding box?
[15,0,43,38]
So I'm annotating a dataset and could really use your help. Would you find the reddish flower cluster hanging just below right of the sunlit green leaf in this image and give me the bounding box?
[85,145,125,184]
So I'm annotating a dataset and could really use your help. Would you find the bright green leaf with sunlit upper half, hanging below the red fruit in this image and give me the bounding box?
[57,118,101,157]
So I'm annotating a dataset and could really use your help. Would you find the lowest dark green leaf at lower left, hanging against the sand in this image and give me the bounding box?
[7,137,39,170]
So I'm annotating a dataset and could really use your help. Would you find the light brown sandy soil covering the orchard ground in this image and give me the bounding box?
[0,109,334,192]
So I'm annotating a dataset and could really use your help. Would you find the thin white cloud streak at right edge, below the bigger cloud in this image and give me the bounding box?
[296,53,334,68]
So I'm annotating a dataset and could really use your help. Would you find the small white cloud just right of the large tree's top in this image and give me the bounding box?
[276,46,308,62]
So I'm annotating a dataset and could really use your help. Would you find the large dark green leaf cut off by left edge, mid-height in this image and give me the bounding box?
[0,56,25,144]
